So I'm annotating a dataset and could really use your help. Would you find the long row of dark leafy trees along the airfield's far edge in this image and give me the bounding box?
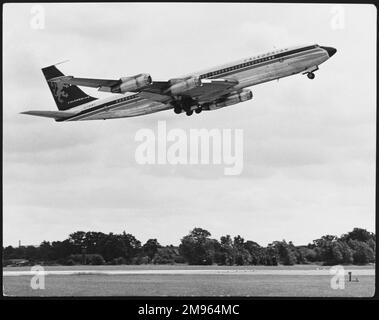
[3,228,376,266]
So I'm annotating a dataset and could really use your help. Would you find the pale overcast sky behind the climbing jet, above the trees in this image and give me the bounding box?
[3,3,376,245]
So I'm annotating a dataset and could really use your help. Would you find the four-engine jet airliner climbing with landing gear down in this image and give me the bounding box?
[22,44,337,122]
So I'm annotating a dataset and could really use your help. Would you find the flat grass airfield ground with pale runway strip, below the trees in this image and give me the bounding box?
[3,265,375,297]
